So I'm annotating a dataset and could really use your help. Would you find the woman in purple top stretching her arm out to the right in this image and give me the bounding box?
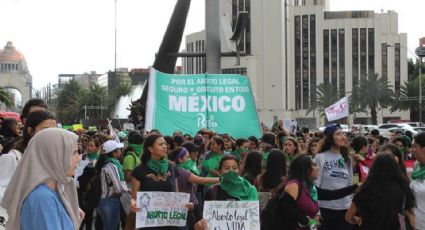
[169,147,220,229]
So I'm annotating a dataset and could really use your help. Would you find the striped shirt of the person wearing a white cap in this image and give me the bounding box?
[100,163,127,199]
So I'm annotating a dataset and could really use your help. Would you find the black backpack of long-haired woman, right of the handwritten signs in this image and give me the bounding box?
[260,181,302,230]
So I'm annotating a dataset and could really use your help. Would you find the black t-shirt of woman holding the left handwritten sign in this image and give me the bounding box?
[131,164,179,192]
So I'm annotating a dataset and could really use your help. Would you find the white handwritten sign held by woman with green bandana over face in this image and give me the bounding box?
[204,201,260,230]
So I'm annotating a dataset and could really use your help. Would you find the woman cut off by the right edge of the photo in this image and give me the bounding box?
[410,132,425,230]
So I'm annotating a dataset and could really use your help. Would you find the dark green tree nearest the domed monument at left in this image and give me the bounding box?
[57,79,87,124]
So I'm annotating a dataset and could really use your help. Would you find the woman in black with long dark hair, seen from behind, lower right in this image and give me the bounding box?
[356,153,415,229]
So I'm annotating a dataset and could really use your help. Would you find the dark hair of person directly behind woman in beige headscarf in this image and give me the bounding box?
[16,110,56,153]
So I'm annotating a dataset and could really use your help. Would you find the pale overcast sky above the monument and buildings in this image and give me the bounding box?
[0,0,425,89]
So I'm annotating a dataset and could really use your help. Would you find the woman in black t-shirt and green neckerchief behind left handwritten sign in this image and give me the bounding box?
[131,134,179,230]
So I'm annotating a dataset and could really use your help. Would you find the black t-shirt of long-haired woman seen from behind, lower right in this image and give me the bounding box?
[353,186,414,230]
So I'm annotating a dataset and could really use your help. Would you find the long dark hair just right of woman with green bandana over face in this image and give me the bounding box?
[261,149,286,189]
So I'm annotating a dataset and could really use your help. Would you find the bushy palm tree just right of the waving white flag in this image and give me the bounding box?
[358,73,395,125]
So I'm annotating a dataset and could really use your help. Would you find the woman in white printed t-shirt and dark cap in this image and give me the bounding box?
[314,124,353,230]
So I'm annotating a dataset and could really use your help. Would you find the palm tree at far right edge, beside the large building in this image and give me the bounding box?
[391,77,425,120]
